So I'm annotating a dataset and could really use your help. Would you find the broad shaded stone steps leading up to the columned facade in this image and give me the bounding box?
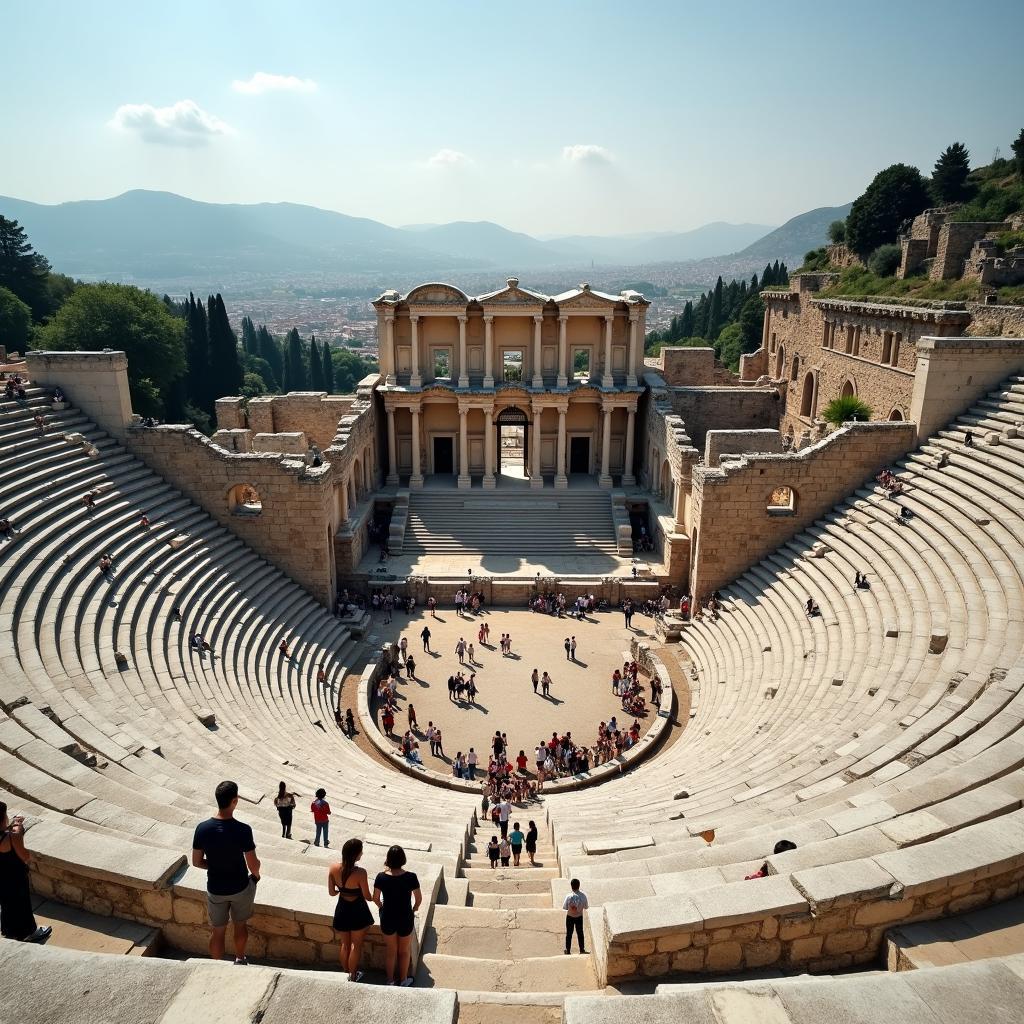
[402,488,617,557]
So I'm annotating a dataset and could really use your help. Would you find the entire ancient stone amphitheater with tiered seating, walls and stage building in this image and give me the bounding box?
[0,279,1024,1024]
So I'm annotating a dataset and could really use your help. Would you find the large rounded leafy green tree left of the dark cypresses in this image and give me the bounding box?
[33,284,185,416]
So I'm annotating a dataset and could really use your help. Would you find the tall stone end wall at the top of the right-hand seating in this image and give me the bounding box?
[910,337,1024,440]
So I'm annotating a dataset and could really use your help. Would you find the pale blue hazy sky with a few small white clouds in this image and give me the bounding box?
[0,0,1024,234]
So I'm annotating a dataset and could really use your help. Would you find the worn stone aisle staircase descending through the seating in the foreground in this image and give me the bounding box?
[417,809,598,1024]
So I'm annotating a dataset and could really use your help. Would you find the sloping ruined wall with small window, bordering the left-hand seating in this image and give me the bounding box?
[124,426,334,607]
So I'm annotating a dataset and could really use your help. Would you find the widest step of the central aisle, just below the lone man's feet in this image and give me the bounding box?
[416,952,598,992]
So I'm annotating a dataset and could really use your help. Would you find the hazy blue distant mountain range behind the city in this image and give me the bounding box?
[0,189,849,283]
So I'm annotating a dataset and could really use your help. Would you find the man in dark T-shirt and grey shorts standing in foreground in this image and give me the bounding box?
[191,781,259,965]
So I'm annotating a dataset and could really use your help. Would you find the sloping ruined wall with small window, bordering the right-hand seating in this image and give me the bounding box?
[690,423,916,597]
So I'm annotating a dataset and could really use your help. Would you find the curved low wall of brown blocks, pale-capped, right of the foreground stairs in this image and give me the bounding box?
[591,811,1024,984]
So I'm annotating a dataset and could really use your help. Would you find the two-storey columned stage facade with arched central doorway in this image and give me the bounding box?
[374,278,648,488]
